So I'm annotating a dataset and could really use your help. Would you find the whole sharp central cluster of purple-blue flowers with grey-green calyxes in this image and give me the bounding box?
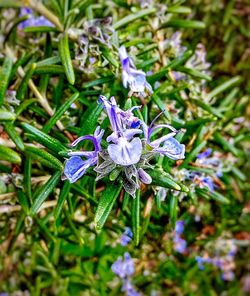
[64,96,185,196]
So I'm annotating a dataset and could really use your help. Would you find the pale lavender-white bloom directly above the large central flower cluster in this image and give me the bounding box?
[119,46,153,97]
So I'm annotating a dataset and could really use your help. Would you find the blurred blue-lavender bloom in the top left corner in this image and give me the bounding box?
[18,7,54,29]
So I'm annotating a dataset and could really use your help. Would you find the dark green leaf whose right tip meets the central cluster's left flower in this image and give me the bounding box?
[24,146,63,170]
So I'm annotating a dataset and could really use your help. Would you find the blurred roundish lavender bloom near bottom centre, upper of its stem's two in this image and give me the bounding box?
[111,252,135,279]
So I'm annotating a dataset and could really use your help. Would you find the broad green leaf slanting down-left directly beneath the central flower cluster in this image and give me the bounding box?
[95,183,122,229]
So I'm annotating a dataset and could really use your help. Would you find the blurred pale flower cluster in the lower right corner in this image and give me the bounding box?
[195,239,237,281]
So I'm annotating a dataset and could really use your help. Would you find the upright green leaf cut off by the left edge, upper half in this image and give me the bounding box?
[0,57,13,106]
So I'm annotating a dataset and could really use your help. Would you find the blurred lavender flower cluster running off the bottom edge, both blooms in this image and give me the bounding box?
[111,252,140,296]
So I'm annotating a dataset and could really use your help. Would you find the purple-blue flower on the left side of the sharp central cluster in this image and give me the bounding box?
[64,127,104,183]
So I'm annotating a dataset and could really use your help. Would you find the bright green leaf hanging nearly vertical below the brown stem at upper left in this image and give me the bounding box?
[59,32,75,84]
